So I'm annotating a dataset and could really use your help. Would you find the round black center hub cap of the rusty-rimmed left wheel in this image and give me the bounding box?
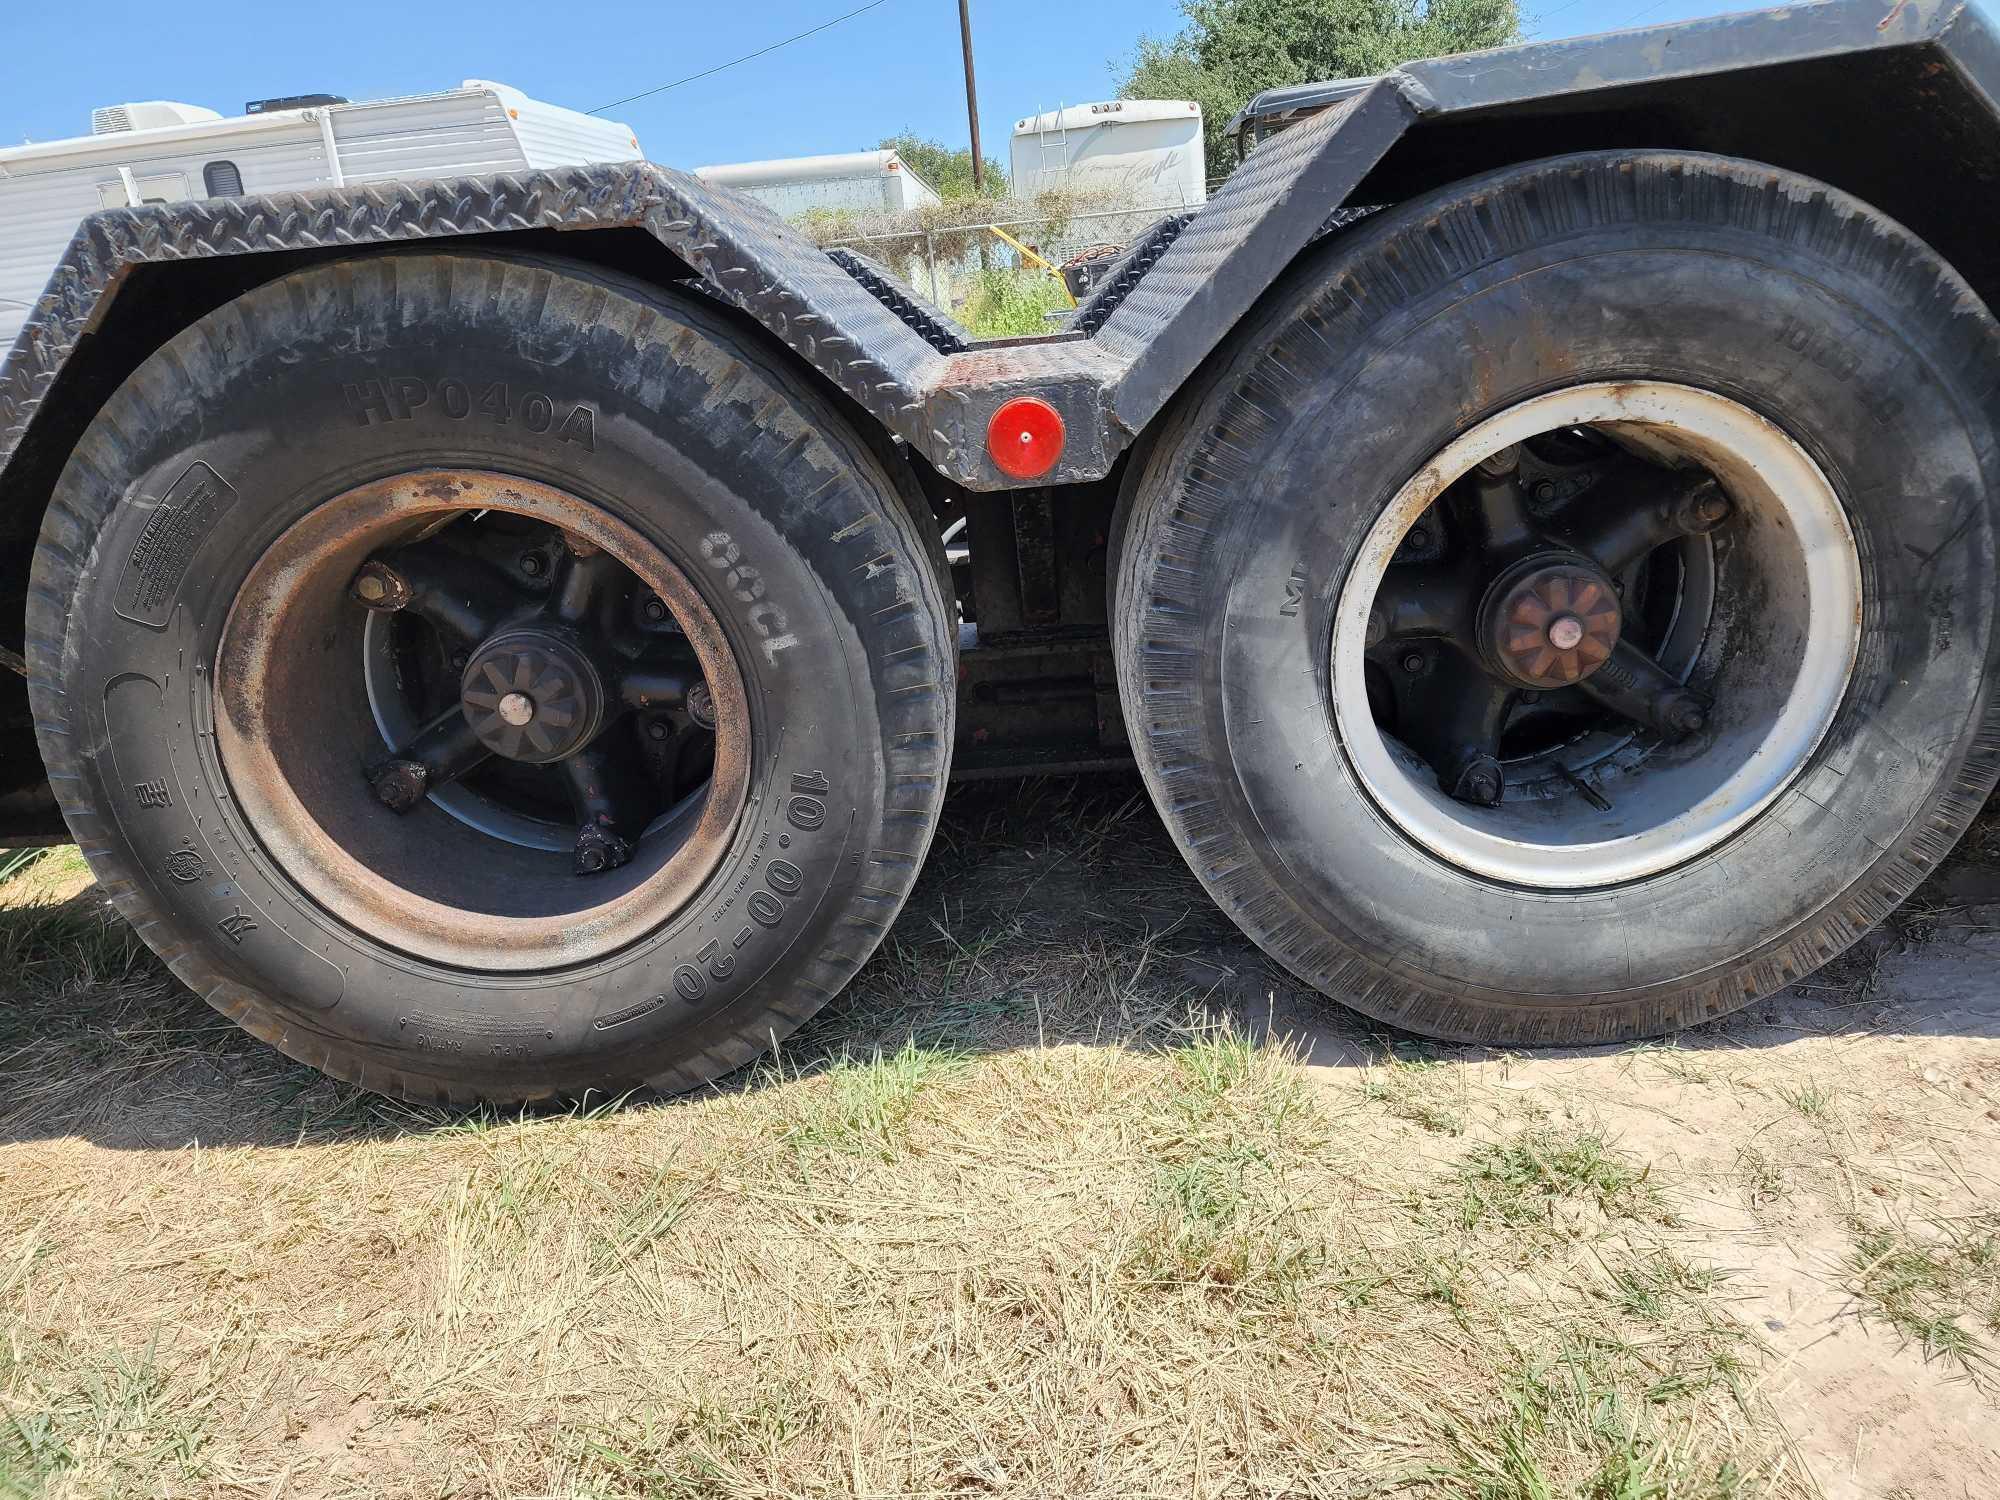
[458,628,604,766]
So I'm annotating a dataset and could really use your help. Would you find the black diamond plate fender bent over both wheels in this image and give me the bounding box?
[11,0,2000,510]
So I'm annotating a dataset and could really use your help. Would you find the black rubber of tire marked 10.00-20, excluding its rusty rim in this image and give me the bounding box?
[28,252,956,1102]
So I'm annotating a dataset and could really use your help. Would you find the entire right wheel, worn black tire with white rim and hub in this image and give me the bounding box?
[1114,152,2000,1046]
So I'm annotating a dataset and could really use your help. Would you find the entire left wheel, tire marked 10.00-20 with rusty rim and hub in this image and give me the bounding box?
[28,252,956,1102]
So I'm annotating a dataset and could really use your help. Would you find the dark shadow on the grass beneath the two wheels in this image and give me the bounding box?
[0,776,2000,1148]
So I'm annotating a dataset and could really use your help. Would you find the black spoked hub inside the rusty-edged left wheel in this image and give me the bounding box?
[348,508,718,874]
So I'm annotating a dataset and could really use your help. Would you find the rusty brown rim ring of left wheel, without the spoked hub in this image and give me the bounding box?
[212,470,750,972]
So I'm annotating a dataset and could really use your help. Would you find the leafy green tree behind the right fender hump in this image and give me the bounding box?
[1128,0,1520,181]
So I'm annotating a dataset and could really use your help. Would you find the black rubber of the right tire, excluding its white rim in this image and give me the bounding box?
[1114,152,2000,1044]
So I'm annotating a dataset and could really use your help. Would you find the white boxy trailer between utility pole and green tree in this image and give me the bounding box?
[1008,98,1208,210]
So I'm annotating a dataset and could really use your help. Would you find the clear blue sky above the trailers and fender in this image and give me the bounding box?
[0,0,1746,166]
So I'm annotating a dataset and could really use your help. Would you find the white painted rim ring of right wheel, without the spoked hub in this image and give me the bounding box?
[1332,382,1862,890]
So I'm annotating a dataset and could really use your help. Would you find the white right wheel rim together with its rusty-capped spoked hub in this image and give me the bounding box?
[1330,380,1862,890]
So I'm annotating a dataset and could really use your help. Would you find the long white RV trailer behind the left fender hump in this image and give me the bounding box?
[0,78,640,350]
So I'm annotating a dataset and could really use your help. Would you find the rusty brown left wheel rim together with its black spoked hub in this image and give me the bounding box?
[212,470,750,972]
